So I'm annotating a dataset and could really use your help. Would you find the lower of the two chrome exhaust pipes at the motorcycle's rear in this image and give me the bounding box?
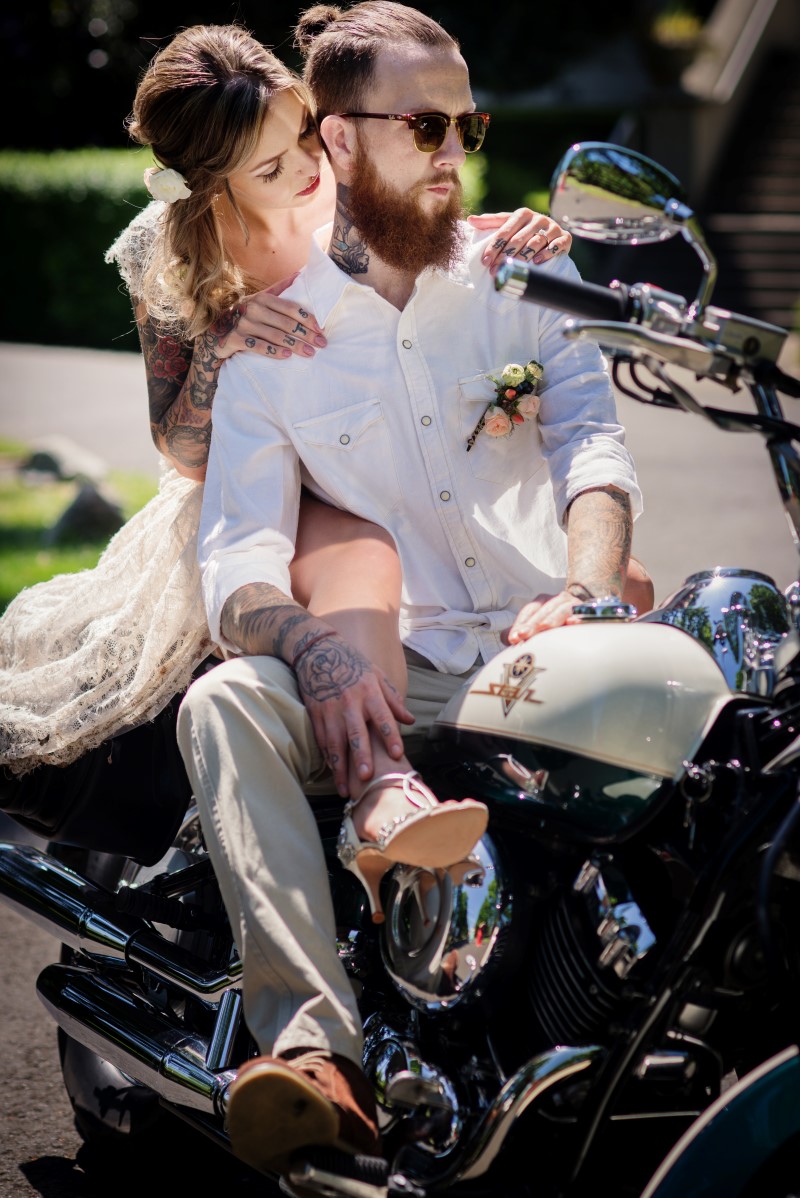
[36,964,235,1119]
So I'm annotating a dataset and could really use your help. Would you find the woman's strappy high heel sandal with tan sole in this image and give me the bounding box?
[337,770,489,924]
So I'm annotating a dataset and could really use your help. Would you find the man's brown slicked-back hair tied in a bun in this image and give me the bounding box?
[295,0,459,120]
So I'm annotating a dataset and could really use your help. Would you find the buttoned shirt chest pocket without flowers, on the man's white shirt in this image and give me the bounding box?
[292,398,401,515]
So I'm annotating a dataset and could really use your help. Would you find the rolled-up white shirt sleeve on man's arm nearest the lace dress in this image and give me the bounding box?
[198,353,299,652]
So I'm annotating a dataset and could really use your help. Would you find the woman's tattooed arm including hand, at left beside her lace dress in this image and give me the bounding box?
[135,279,327,483]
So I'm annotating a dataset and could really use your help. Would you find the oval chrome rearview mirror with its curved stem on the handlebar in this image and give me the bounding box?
[550,141,717,311]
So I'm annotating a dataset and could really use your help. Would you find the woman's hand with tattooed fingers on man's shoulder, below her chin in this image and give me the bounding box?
[210,274,328,361]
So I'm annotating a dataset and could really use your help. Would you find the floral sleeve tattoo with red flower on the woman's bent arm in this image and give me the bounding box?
[139,306,219,470]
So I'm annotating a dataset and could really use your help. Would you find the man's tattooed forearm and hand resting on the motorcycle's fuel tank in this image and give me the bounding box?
[508,486,634,645]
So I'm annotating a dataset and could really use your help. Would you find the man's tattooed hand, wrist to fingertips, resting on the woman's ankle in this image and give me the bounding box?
[292,630,414,797]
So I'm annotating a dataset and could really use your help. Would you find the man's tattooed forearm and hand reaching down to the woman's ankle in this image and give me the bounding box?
[220,582,413,795]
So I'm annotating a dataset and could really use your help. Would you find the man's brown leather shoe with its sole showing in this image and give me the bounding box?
[221,1049,380,1173]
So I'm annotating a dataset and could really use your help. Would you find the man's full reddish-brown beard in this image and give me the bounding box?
[346,144,463,276]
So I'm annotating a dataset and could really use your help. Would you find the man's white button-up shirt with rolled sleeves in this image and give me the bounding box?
[200,226,641,673]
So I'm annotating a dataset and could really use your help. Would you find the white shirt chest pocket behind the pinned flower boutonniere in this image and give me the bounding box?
[459,367,545,486]
